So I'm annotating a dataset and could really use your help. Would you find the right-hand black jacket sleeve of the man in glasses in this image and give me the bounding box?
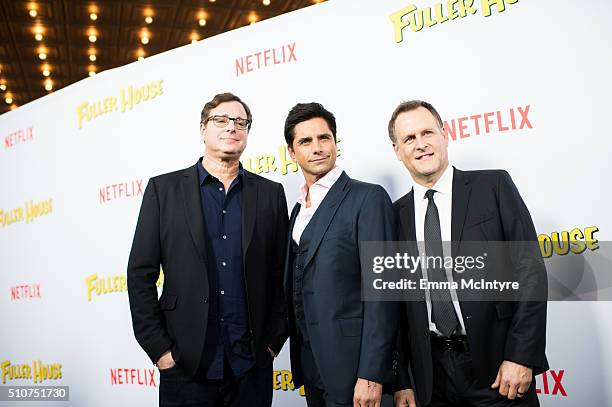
[268,184,289,355]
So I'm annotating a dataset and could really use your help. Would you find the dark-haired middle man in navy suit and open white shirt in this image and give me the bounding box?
[285,103,397,407]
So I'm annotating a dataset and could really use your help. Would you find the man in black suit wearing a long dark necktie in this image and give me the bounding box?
[389,101,548,406]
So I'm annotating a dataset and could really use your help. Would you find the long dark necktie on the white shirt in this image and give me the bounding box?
[424,189,459,337]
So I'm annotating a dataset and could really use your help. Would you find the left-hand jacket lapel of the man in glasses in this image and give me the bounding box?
[182,162,206,264]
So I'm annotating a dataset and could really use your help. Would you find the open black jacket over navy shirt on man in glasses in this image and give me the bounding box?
[127,163,288,374]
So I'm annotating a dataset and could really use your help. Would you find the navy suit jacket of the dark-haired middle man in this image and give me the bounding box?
[285,172,397,402]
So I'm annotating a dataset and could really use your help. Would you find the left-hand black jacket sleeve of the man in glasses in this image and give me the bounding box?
[127,179,172,363]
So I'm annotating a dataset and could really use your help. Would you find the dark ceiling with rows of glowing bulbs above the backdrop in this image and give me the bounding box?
[0,0,322,114]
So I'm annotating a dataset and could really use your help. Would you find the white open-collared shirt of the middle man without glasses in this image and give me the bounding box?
[291,167,342,245]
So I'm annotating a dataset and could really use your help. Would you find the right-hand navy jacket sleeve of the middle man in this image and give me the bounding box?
[357,186,398,383]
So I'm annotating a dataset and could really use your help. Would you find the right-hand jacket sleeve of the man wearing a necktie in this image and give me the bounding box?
[497,171,548,374]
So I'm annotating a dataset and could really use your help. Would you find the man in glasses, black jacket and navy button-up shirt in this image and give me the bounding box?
[127,93,288,407]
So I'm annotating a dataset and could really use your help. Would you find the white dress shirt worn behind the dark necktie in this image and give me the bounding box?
[414,164,466,335]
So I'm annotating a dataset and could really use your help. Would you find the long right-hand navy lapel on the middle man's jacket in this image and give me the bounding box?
[304,171,350,268]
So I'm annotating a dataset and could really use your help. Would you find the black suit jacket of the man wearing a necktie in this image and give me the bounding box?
[394,169,548,405]
